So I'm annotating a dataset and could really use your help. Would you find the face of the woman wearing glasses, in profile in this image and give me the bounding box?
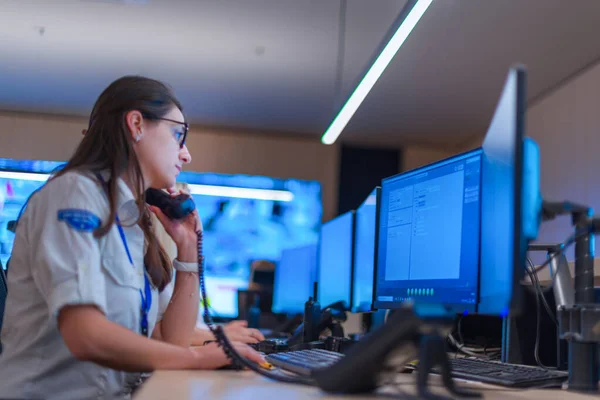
[130,107,192,189]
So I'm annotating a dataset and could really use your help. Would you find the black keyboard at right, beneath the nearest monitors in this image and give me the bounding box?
[442,358,568,388]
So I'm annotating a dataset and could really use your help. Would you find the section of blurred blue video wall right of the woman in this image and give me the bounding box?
[178,172,322,318]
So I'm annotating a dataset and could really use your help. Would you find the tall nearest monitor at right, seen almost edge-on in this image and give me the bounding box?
[478,68,528,315]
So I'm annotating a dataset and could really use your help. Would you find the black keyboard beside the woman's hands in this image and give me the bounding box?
[265,349,344,376]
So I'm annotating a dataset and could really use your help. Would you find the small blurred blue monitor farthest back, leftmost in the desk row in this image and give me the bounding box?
[273,244,317,314]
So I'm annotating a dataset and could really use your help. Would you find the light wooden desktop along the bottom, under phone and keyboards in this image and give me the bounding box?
[134,371,598,400]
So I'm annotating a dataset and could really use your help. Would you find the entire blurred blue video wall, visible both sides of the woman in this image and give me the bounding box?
[0,159,322,318]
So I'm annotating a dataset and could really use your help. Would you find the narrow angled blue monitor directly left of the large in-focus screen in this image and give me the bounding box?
[351,187,381,312]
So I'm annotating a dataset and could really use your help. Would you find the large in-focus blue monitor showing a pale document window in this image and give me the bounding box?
[374,149,481,312]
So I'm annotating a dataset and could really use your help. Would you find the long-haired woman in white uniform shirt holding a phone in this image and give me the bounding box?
[0,77,262,399]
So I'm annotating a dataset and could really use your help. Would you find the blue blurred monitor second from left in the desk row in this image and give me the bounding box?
[317,211,355,310]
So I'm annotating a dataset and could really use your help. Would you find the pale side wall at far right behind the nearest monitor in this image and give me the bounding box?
[527,60,600,266]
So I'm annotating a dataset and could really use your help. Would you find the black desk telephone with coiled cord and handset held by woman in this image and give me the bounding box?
[146,189,477,397]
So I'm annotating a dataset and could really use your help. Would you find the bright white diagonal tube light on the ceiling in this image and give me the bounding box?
[321,0,432,144]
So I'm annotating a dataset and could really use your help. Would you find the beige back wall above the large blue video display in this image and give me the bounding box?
[0,113,339,220]
